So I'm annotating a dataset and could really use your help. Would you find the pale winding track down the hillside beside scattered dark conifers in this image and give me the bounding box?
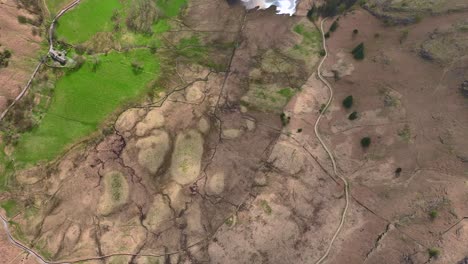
[314,18,349,264]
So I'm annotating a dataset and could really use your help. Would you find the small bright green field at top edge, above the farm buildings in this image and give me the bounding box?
[56,0,122,43]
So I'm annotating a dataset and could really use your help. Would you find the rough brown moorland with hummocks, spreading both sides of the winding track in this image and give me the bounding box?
[2,0,468,263]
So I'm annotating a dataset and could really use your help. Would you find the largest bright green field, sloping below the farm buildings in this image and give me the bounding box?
[14,49,159,164]
